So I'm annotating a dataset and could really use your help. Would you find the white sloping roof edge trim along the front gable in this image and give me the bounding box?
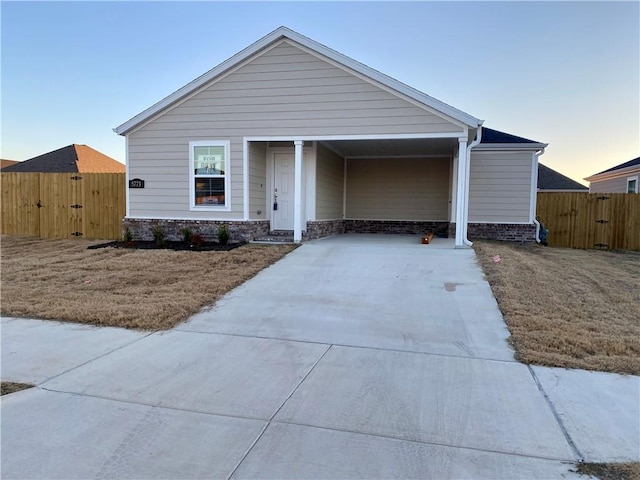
[113,27,483,135]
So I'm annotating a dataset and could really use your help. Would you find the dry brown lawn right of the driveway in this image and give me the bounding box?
[474,241,640,375]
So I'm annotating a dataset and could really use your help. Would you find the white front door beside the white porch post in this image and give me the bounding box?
[272,152,295,230]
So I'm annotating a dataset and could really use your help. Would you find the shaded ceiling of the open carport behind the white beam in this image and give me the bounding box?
[320,138,458,158]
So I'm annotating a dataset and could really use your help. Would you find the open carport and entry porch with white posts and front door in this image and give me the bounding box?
[245,131,481,247]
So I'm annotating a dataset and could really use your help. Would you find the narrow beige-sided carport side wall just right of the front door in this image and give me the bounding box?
[316,144,344,220]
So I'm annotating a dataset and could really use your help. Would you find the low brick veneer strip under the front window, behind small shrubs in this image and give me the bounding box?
[122,218,269,241]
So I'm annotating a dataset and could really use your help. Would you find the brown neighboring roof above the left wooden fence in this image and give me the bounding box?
[2,144,125,173]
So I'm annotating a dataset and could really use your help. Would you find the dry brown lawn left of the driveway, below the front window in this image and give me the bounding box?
[0,236,294,330]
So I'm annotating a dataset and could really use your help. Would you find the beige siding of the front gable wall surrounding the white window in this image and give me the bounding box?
[129,42,461,219]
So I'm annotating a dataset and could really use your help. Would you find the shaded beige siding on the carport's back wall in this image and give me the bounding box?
[346,158,450,221]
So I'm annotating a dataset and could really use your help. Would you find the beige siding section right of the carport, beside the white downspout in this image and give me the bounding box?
[469,152,533,223]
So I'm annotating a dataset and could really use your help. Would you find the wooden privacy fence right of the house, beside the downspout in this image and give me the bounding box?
[537,192,640,250]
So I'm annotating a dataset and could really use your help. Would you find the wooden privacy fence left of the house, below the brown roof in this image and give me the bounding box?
[1,172,126,239]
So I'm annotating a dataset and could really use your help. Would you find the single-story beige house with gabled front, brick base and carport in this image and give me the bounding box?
[114,27,547,247]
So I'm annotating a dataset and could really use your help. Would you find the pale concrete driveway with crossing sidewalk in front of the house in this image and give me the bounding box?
[1,235,638,479]
